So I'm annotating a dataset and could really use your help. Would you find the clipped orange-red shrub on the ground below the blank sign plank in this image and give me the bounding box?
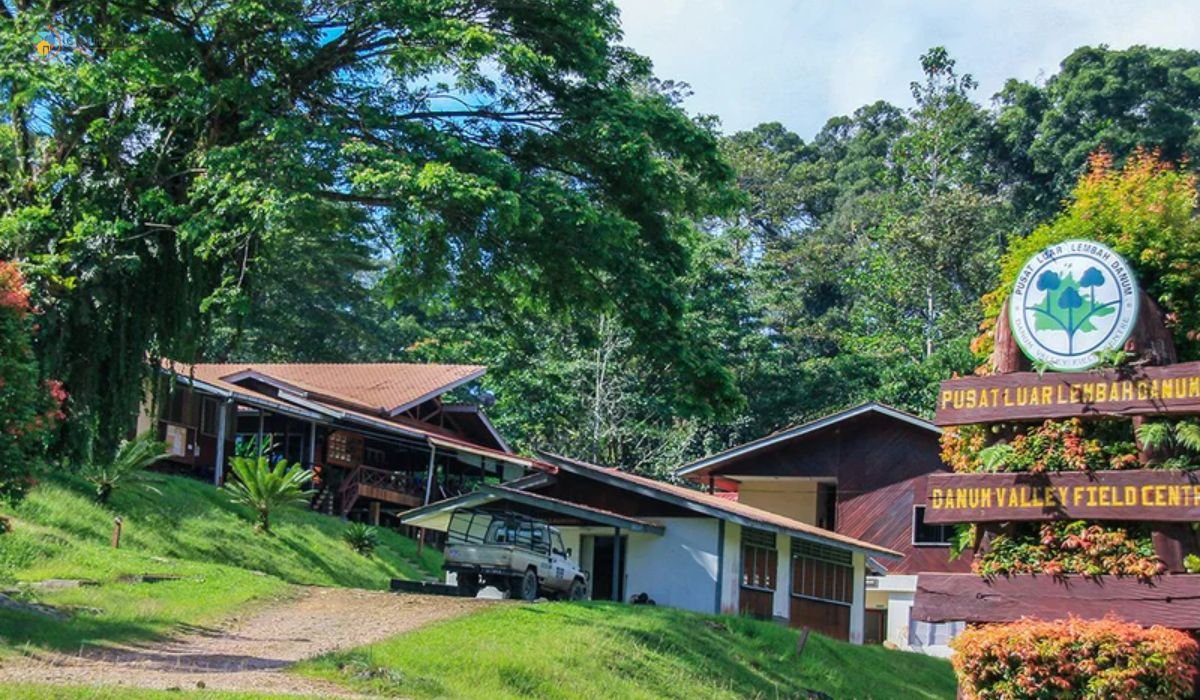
[950,617,1200,700]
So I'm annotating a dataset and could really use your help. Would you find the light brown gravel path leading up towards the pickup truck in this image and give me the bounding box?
[0,587,490,698]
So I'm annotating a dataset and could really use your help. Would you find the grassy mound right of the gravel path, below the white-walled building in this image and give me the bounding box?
[296,603,954,700]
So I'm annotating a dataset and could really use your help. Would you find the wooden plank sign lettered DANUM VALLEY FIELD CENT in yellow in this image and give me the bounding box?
[925,469,1200,523]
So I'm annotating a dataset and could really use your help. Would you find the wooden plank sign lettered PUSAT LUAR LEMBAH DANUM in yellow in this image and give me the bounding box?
[934,363,1200,425]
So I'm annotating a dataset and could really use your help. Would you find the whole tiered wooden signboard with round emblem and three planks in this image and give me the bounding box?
[912,240,1200,629]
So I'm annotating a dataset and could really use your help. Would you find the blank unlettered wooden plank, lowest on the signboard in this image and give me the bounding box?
[912,574,1200,629]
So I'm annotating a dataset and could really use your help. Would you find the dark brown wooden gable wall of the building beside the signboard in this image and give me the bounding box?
[714,413,971,574]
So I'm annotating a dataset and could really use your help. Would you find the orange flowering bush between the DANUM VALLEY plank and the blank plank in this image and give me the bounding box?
[971,520,1164,579]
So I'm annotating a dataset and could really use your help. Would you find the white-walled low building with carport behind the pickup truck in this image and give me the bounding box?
[400,453,899,642]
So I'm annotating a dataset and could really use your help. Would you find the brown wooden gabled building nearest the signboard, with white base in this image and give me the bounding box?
[677,403,971,656]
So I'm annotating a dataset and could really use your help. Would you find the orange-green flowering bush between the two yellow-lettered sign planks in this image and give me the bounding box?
[942,418,1140,474]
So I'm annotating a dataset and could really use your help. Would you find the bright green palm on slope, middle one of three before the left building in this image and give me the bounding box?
[224,449,316,534]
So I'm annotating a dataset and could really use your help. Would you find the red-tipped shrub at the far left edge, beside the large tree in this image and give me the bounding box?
[0,261,67,501]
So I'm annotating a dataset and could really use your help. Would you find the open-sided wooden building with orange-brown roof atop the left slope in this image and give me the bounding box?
[138,363,536,523]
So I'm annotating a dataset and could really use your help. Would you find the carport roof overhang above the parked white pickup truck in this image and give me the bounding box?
[398,486,666,536]
